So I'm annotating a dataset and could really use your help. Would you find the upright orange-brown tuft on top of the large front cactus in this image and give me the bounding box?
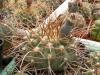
[41,15,63,41]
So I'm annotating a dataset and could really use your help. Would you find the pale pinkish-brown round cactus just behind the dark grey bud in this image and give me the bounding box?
[69,12,87,33]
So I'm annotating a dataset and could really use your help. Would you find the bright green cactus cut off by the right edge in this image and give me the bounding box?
[90,20,100,41]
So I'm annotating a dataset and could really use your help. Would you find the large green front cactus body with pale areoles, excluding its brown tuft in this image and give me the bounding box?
[19,26,77,71]
